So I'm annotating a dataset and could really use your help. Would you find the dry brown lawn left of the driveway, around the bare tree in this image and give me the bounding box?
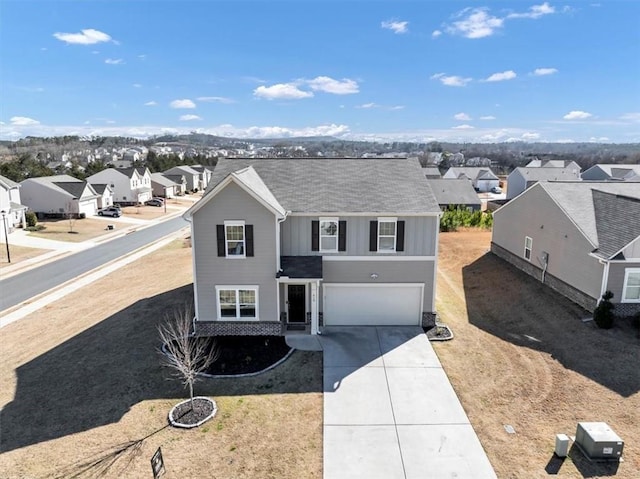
[0,241,322,479]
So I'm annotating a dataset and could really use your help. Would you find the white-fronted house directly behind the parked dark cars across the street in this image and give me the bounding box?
[87,168,152,205]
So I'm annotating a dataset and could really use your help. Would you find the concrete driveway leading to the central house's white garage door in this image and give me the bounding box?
[319,327,496,479]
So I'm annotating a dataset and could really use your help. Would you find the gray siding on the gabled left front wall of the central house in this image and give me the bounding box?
[192,183,278,321]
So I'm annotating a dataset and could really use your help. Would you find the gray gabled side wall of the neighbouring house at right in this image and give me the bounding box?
[492,186,604,299]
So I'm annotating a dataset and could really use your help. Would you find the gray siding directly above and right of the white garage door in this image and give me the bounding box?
[321,260,435,312]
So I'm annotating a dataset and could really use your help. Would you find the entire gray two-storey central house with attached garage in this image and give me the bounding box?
[184,159,441,335]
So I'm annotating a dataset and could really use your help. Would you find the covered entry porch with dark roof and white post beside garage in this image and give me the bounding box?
[276,256,322,334]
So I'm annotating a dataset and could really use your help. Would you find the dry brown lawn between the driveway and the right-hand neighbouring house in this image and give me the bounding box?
[435,231,640,479]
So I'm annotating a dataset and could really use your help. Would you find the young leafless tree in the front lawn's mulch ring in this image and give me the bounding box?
[158,305,220,409]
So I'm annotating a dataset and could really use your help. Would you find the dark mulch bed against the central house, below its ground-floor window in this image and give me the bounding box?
[206,336,291,375]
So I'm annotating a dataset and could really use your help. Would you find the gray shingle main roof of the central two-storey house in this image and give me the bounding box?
[205,158,440,214]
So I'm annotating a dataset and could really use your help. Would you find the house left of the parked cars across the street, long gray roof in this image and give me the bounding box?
[20,175,99,217]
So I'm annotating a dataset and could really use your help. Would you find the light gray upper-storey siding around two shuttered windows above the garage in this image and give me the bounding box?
[281,216,438,256]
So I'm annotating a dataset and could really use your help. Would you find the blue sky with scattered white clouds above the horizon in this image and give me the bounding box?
[0,0,640,143]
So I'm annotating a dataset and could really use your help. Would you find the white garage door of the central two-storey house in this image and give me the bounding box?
[322,283,424,326]
